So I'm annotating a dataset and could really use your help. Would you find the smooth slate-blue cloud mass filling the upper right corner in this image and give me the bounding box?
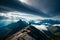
[30,0,60,16]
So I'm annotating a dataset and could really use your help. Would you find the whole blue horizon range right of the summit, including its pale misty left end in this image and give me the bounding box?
[29,19,60,25]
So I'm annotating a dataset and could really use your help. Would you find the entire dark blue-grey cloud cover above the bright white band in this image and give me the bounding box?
[0,0,60,19]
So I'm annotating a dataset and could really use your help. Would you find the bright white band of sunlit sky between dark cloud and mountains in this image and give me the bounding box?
[0,12,44,21]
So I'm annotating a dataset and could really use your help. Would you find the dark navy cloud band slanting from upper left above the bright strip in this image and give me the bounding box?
[0,0,49,17]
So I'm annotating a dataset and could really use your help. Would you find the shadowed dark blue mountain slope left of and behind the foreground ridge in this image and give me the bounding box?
[0,20,28,40]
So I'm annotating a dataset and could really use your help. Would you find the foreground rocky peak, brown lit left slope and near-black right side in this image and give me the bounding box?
[6,26,48,40]
